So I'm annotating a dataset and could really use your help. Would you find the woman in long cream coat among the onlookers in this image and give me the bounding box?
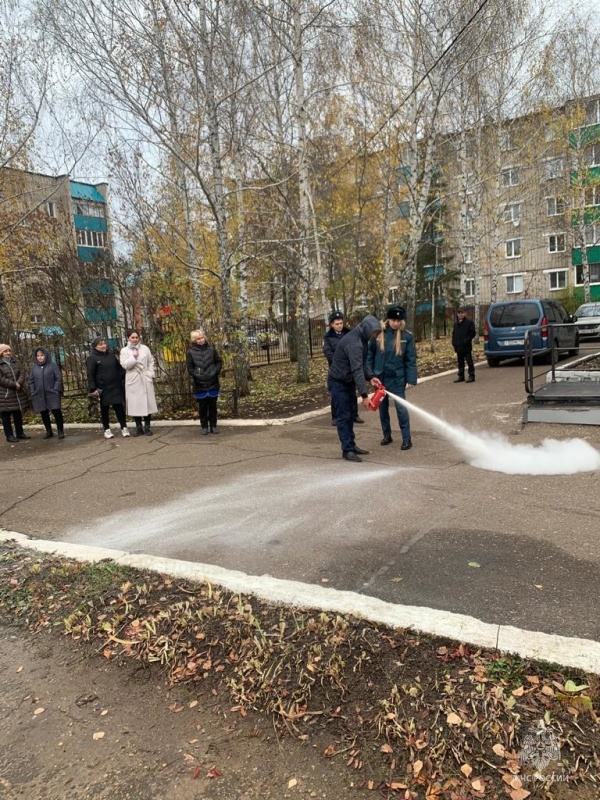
[119,330,158,436]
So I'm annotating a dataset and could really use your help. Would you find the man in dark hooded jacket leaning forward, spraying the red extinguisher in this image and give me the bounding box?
[328,314,381,461]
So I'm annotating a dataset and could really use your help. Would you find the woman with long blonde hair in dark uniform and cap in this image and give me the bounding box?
[367,306,417,450]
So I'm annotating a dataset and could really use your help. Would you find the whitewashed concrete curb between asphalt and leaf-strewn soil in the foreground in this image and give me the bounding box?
[0,529,600,675]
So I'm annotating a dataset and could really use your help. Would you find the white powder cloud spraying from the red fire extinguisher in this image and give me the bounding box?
[388,392,600,475]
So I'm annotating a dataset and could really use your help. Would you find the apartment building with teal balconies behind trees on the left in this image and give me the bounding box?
[0,168,117,335]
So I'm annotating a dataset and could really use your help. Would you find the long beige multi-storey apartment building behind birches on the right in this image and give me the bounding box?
[440,97,600,305]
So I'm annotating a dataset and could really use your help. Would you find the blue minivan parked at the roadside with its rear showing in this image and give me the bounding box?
[483,299,579,367]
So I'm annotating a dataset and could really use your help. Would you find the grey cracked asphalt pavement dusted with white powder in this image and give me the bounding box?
[0,363,600,664]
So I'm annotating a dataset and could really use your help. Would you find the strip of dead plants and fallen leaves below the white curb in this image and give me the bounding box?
[0,544,600,800]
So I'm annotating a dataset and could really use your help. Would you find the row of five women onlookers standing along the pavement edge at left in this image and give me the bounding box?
[0,330,222,443]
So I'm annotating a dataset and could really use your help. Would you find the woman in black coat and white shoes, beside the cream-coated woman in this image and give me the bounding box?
[85,337,130,439]
